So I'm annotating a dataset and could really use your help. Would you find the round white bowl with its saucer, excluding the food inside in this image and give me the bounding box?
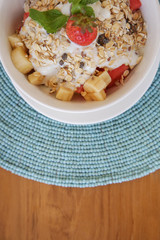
[0,0,160,124]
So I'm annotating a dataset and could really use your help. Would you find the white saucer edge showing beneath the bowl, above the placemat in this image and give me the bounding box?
[11,52,159,125]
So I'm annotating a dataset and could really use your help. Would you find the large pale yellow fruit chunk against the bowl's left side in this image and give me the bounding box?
[11,47,33,74]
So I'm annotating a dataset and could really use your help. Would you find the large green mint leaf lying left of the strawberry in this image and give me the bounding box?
[29,9,69,33]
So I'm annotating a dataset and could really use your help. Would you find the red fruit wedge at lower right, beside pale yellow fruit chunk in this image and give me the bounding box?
[107,64,129,87]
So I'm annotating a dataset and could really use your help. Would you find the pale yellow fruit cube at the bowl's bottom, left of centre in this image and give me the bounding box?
[56,86,74,101]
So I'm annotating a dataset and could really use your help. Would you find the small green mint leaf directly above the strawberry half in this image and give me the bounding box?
[71,4,95,17]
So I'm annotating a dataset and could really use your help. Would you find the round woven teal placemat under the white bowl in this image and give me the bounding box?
[0,62,160,187]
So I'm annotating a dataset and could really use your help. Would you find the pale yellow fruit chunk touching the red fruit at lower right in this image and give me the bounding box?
[84,71,111,93]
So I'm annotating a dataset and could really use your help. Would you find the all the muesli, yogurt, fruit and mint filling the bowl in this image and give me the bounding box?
[9,0,147,101]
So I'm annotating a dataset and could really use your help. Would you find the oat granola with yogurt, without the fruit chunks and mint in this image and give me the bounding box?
[10,0,147,100]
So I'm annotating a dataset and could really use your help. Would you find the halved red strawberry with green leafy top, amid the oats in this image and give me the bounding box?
[66,14,97,46]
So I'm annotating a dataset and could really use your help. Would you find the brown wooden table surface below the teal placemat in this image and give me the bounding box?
[0,169,160,240]
